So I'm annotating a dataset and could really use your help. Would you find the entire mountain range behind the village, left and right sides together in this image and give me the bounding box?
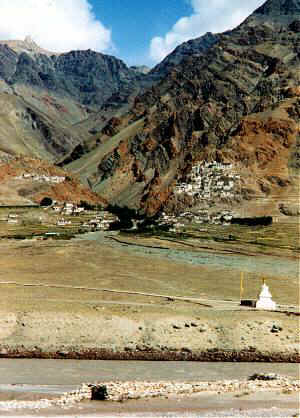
[0,0,300,215]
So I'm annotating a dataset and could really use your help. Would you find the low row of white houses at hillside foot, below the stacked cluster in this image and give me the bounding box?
[157,209,234,232]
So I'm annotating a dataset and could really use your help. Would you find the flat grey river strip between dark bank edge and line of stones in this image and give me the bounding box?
[0,359,299,391]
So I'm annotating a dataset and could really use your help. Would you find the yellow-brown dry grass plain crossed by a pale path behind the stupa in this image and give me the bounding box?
[0,232,299,311]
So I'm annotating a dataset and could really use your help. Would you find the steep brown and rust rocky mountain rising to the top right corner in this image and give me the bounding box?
[70,0,300,215]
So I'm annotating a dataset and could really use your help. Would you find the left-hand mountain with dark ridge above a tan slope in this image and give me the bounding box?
[0,38,141,161]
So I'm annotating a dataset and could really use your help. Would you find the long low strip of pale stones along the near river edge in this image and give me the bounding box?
[0,373,300,411]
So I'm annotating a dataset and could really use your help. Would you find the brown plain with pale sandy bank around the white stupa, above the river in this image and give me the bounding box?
[0,230,299,361]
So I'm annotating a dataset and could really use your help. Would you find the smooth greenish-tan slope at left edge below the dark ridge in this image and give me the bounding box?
[0,89,82,162]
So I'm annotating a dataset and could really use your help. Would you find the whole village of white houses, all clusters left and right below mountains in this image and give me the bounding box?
[0,161,241,236]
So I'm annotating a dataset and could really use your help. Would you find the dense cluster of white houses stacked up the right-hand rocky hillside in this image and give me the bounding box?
[174,161,240,201]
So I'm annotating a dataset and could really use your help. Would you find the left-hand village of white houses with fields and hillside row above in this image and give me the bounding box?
[0,168,118,235]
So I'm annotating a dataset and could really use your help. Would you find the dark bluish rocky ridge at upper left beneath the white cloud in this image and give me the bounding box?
[0,44,138,106]
